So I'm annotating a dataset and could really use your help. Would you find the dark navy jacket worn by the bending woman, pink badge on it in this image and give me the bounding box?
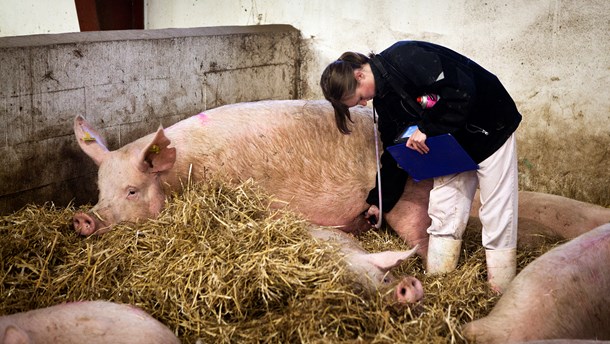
[367,41,521,211]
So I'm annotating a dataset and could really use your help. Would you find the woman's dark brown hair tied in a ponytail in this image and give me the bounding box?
[320,51,369,134]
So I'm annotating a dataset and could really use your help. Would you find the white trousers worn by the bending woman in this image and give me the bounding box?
[428,133,519,250]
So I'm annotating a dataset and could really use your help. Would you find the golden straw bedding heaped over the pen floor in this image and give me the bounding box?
[0,181,554,343]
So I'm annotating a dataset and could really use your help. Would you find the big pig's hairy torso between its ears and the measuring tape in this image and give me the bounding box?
[167,100,376,225]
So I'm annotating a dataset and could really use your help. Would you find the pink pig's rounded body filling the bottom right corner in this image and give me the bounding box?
[463,223,610,343]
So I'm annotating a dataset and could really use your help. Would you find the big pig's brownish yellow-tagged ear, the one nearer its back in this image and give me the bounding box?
[139,127,176,173]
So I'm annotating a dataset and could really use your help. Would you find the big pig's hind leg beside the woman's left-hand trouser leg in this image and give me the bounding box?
[385,178,432,260]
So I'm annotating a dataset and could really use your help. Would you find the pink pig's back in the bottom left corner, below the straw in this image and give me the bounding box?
[0,301,180,344]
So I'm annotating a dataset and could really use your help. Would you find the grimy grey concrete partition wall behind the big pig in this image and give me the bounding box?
[0,25,300,213]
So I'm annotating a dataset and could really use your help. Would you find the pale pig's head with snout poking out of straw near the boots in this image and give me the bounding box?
[309,228,424,304]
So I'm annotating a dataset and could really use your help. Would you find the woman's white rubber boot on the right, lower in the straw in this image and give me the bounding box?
[485,248,517,294]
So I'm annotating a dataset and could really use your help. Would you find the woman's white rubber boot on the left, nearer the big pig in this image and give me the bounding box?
[426,235,462,274]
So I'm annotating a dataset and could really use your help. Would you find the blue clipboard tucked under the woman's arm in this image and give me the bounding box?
[387,134,479,180]
